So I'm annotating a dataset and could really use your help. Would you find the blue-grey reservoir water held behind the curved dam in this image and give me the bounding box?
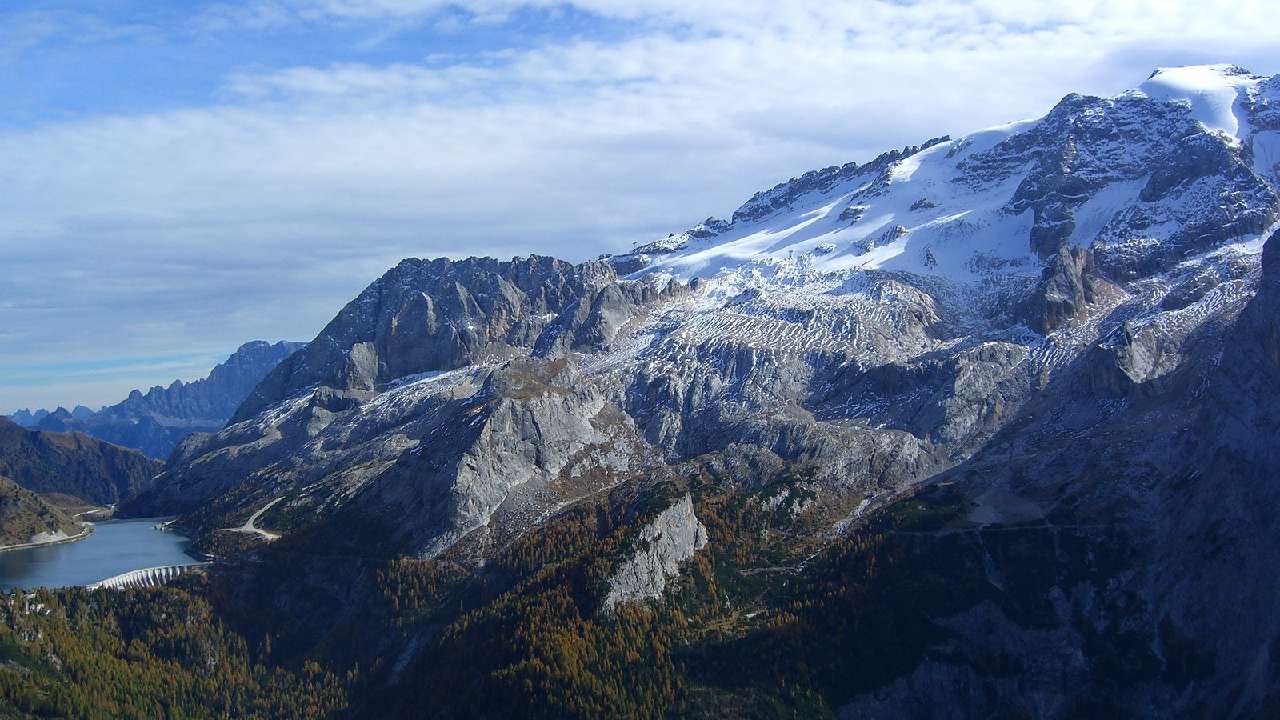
[0,520,198,589]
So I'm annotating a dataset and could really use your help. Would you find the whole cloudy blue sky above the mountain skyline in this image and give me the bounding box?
[0,0,1280,411]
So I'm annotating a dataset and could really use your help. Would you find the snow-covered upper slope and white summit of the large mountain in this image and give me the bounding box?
[627,65,1280,283]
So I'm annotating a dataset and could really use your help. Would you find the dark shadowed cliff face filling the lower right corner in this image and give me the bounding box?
[819,226,1280,717]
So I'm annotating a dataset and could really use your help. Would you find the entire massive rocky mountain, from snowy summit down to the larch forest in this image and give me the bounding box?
[129,65,1280,717]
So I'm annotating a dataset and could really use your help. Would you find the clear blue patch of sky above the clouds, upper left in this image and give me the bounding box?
[0,0,627,129]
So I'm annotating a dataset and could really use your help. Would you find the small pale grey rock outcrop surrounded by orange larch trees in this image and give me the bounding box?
[604,495,707,610]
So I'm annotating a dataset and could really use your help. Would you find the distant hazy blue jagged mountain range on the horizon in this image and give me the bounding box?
[9,340,306,459]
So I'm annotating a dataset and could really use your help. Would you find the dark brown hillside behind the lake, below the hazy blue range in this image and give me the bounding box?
[0,418,163,505]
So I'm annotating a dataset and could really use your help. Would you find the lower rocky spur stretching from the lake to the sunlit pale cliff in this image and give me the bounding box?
[124,359,648,556]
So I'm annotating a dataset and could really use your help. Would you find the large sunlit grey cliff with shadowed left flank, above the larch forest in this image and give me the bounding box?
[356,361,643,556]
